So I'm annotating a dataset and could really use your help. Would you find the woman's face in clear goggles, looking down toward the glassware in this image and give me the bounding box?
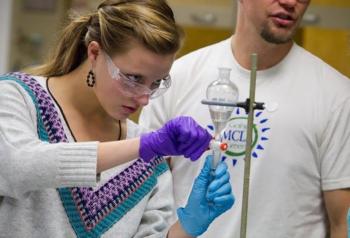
[93,42,175,120]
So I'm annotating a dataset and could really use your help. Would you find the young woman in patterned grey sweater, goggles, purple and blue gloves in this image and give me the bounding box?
[0,0,234,238]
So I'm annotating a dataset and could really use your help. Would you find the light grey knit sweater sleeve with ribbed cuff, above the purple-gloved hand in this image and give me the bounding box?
[0,81,98,198]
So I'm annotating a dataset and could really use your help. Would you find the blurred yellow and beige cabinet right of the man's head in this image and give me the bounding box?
[302,0,350,77]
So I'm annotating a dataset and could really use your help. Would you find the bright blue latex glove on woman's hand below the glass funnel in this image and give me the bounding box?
[177,155,235,236]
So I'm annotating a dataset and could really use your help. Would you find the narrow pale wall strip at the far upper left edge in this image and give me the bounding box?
[0,0,12,74]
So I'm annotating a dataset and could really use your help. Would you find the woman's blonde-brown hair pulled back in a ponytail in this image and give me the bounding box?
[31,0,183,77]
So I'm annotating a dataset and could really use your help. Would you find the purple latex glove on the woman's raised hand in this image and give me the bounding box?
[139,116,212,162]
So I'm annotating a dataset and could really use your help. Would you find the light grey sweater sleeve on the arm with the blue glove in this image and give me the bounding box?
[133,170,174,238]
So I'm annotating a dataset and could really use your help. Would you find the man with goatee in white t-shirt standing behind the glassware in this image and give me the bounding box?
[140,0,350,238]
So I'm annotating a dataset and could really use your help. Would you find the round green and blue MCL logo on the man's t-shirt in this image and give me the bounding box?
[208,108,270,166]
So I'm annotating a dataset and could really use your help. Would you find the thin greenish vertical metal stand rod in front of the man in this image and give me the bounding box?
[240,54,258,238]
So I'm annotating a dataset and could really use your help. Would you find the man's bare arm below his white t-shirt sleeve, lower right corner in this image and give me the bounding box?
[323,189,350,238]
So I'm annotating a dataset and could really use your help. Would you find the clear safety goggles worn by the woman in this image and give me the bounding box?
[104,53,171,99]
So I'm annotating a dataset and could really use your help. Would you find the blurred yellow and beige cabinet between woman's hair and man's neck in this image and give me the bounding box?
[168,0,236,56]
